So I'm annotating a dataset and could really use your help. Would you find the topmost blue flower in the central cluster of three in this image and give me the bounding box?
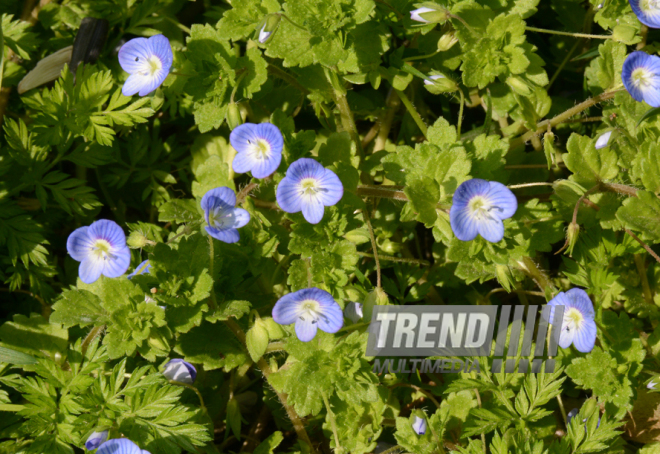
[229,123,284,178]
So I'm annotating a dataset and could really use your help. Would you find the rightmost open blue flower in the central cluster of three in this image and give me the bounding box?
[276,158,344,224]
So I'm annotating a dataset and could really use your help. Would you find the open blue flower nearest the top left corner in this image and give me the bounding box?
[119,35,173,96]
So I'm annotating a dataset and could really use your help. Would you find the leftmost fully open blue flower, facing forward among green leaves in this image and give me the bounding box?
[66,219,131,284]
